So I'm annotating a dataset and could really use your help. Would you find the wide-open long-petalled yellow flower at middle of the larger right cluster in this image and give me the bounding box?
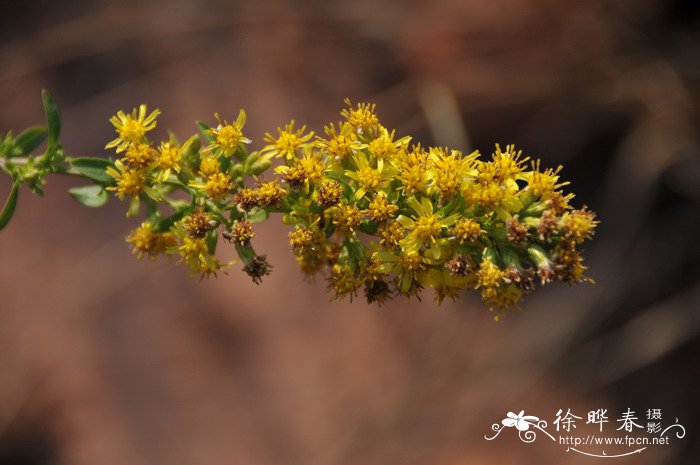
[396,197,459,253]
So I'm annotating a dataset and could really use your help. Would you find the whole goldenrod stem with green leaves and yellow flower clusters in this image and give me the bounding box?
[0,92,598,318]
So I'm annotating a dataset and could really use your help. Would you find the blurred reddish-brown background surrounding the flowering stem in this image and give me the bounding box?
[0,0,700,465]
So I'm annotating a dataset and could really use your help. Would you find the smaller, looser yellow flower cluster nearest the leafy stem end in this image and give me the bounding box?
[106,105,274,282]
